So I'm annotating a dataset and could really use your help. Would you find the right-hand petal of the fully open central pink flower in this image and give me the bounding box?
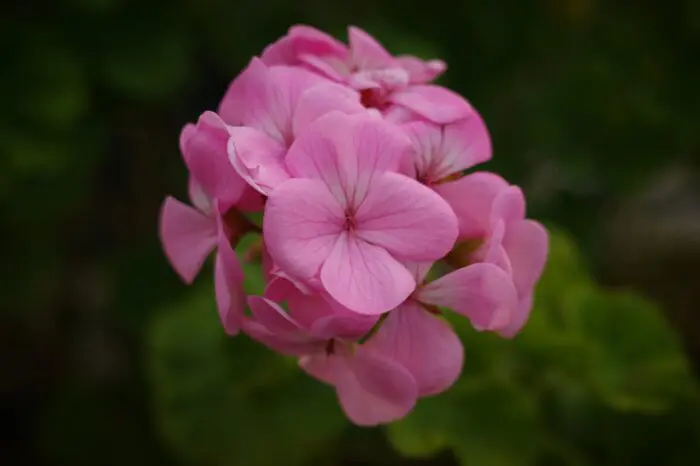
[355,172,458,261]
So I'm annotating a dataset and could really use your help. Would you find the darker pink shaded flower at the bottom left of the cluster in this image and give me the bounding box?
[243,290,417,425]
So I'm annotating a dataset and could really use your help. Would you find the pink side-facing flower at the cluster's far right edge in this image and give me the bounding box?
[435,172,548,337]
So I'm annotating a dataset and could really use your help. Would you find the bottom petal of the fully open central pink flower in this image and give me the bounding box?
[322,232,416,315]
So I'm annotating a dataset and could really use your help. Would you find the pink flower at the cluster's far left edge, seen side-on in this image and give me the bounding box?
[160,116,256,334]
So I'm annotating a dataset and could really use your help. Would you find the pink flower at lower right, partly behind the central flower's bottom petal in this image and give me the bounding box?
[365,263,517,397]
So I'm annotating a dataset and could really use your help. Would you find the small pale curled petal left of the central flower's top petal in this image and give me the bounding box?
[227,126,289,195]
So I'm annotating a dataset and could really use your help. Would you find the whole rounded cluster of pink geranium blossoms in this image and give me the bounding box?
[160,26,547,425]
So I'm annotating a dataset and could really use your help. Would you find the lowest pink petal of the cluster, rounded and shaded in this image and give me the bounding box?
[336,346,418,426]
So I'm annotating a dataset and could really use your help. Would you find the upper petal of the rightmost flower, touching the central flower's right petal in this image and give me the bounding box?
[433,172,509,239]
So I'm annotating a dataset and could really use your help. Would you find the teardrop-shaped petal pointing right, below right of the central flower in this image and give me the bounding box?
[417,263,517,330]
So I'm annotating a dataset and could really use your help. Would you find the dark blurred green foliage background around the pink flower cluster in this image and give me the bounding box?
[0,0,700,466]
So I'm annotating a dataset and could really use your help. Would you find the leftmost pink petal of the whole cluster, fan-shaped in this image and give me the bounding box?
[160,197,217,283]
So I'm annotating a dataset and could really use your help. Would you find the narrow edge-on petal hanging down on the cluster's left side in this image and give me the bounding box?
[214,231,246,335]
